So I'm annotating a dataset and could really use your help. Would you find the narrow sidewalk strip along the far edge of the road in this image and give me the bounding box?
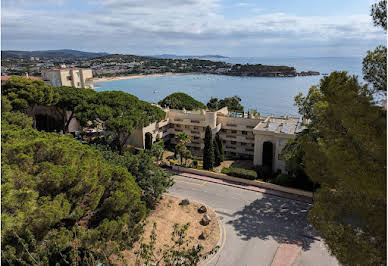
[169,170,312,203]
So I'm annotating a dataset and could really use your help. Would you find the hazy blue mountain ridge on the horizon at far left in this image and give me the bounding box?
[1,49,108,59]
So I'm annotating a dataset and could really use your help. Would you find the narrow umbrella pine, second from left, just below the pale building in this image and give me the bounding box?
[54,87,96,133]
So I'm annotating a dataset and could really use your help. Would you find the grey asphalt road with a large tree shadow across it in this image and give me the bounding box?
[169,176,339,266]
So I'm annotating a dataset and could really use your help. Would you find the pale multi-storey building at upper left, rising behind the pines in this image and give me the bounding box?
[42,68,94,89]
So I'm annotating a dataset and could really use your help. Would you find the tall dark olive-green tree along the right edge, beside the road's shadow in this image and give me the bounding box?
[298,72,387,265]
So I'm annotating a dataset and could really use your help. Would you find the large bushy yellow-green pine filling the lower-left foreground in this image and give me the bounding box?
[1,121,145,265]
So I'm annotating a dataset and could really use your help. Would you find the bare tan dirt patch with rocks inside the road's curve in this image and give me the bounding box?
[115,195,220,265]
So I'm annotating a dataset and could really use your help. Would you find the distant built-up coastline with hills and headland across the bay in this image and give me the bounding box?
[1,49,320,78]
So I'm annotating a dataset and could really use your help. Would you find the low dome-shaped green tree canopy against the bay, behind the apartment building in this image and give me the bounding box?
[158,92,206,110]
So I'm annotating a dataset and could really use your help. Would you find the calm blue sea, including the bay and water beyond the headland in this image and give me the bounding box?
[95,57,362,115]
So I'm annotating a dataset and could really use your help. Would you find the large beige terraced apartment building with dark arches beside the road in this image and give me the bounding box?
[128,107,302,172]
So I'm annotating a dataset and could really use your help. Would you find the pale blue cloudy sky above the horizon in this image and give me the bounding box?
[1,0,386,57]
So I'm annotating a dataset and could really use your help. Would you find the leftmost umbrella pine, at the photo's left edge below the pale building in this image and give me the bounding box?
[2,76,58,128]
